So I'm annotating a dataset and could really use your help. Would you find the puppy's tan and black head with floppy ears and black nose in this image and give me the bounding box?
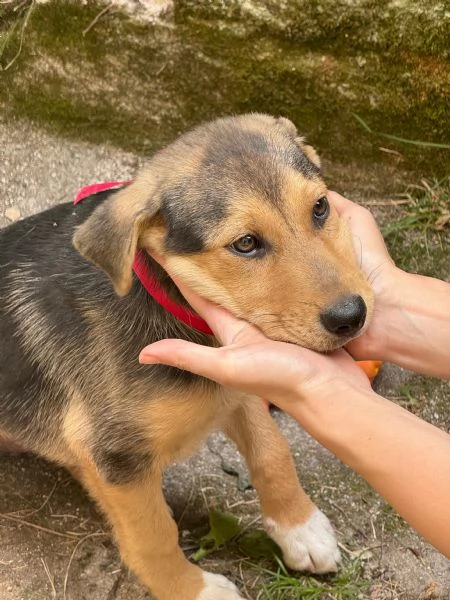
[74,114,373,351]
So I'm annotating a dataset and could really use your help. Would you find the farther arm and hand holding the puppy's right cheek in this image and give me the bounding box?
[329,192,450,379]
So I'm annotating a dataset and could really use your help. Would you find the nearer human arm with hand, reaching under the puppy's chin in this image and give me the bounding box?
[140,285,450,557]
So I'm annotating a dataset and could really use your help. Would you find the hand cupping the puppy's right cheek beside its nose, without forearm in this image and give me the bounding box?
[328,192,405,360]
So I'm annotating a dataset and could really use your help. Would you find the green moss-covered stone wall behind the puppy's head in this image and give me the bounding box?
[0,0,450,180]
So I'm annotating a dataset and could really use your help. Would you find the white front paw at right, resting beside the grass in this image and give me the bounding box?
[264,508,341,573]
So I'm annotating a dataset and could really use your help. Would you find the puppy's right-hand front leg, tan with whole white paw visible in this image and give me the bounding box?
[225,397,339,573]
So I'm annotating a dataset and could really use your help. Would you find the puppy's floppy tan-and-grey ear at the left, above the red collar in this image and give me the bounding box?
[73,177,159,296]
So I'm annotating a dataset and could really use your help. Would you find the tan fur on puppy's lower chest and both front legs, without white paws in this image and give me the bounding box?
[70,392,314,600]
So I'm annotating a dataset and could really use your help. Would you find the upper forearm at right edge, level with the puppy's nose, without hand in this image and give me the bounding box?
[368,271,450,379]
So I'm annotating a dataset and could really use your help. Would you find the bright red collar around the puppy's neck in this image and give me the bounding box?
[74,181,214,335]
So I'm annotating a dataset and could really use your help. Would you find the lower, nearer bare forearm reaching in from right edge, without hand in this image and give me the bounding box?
[290,388,450,557]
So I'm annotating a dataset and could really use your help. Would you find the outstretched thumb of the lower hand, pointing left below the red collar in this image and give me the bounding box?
[139,339,232,384]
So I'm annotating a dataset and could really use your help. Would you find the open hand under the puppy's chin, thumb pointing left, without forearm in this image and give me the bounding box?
[139,257,370,418]
